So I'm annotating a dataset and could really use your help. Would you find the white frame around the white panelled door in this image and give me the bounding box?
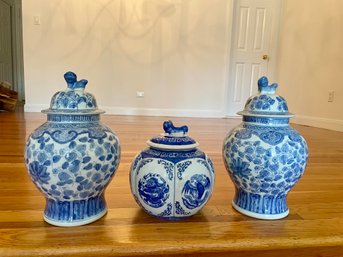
[224,0,284,118]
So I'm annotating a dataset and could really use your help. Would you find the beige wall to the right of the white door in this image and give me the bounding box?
[278,0,343,131]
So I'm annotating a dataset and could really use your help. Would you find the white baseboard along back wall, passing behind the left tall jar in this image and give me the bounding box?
[24,104,225,118]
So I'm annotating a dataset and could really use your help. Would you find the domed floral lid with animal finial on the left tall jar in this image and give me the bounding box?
[42,71,104,115]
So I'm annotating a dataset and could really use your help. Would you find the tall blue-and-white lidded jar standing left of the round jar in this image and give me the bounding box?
[25,72,120,226]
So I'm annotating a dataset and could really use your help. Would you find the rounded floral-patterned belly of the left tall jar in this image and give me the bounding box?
[25,123,120,201]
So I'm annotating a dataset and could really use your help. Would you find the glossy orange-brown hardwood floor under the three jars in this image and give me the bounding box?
[0,110,343,257]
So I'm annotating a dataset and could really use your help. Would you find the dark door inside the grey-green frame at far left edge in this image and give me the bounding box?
[0,0,13,85]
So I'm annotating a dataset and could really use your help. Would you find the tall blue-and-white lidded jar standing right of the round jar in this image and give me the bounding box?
[223,77,308,220]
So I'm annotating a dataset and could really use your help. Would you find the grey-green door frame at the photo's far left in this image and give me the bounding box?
[0,0,25,102]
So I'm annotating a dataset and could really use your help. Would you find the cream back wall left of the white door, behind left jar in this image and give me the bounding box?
[23,0,232,117]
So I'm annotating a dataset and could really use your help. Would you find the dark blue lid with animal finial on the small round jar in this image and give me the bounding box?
[147,120,199,150]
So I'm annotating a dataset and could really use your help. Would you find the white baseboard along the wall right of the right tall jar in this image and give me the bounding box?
[291,115,343,132]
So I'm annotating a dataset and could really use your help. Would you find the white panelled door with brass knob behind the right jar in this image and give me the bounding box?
[227,0,281,116]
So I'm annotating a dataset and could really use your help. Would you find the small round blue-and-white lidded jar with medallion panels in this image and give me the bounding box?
[130,121,215,220]
